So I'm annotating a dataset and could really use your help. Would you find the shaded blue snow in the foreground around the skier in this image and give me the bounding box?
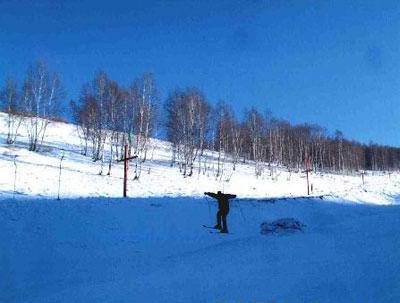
[0,197,400,303]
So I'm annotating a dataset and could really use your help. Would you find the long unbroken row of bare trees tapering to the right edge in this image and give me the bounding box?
[165,100,400,177]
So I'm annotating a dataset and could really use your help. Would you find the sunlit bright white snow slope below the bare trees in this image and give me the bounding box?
[0,114,400,204]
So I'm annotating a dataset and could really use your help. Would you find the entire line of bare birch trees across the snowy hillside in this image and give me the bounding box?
[0,62,400,178]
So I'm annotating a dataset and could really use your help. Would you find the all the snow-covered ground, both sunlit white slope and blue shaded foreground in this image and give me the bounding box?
[0,114,400,303]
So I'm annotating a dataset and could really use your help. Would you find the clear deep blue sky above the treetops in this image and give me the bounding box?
[0,0,400,146]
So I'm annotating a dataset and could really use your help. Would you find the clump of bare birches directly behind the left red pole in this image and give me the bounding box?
[71,72,159,178]
